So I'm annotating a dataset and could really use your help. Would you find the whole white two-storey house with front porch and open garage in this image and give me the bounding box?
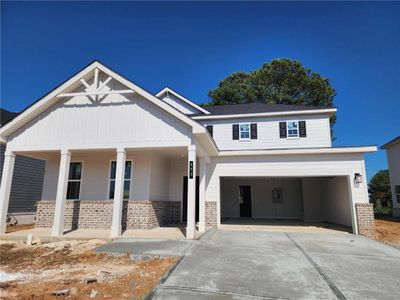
[0,61,376,238]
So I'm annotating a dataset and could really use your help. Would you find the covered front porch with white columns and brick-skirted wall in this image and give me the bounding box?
[1,145,211,239]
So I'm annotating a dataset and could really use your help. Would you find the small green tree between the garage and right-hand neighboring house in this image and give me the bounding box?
[368,170,392,214]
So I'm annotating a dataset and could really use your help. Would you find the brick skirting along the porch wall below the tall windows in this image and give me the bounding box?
[36,200,181,230]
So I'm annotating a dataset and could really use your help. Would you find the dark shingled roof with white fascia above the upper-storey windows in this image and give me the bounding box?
[191,103,337,120]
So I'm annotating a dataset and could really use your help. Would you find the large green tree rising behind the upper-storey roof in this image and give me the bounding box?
[208,58,336,125]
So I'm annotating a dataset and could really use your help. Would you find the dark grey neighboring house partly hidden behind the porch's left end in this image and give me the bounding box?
[0,108,45,224]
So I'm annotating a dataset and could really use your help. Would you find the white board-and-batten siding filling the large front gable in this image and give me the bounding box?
[8,88,192,150]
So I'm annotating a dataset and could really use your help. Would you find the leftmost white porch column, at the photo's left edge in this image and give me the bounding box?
[0,151,15,234]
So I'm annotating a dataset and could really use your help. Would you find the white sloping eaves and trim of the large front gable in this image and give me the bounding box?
[0,60,206,138]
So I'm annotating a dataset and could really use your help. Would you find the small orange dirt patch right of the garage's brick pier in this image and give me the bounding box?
[375,217,400,248]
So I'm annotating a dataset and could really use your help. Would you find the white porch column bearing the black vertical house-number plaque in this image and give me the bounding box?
[186,145,196,239]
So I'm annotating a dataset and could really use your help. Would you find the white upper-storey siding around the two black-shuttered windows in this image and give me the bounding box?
[199,114,332,150]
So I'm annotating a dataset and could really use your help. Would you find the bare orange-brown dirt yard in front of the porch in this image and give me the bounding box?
[0,240,178,299]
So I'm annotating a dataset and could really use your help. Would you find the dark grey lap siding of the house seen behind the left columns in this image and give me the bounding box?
[0,144,46,213]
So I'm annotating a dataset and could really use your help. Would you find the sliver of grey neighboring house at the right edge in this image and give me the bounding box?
[381,136,400,217]
